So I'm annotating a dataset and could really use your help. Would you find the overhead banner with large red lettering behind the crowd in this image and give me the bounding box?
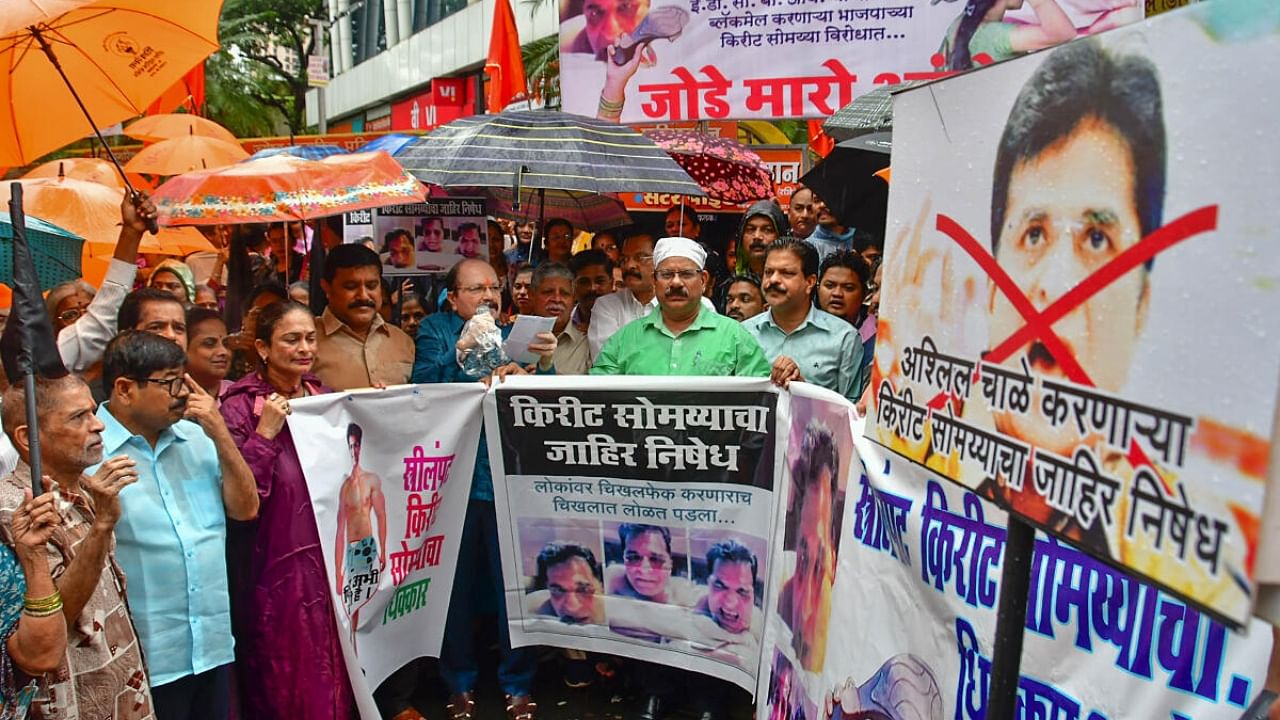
[559,0,1143,123]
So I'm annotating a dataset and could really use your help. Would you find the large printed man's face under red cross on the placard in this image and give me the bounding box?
[987,41,1166,533]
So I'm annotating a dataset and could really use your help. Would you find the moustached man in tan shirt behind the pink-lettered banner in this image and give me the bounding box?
[315,245,413,389]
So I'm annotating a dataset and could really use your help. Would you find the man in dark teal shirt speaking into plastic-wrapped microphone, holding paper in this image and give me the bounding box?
[413,259,556,720]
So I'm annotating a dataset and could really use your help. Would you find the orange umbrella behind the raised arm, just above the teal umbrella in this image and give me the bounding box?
[0,178,214,256]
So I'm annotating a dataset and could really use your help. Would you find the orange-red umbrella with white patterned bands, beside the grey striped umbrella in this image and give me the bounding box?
[156,152,426,229]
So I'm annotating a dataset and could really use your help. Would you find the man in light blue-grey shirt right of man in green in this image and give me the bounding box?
[742,237,863,402]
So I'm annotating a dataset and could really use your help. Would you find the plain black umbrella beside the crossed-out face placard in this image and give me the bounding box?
[800,132,892,237]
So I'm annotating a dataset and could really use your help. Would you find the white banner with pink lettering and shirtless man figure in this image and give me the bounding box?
[289,383,484,720]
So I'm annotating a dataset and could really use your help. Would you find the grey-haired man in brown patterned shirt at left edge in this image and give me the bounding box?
[0,375,155,720]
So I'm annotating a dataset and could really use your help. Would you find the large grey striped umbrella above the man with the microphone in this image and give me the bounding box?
[396,110,705,196]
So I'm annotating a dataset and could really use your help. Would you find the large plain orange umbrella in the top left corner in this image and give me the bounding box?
[0,0,223,165]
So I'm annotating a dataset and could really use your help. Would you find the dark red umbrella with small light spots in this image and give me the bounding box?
[644,129,773,202]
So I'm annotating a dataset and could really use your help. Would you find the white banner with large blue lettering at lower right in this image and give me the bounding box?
[756,409,1271,720]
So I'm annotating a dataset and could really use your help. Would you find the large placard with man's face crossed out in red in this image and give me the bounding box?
[868,0,1280,625]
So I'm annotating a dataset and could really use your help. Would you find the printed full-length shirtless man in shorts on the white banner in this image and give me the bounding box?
[334,423,387,642]
